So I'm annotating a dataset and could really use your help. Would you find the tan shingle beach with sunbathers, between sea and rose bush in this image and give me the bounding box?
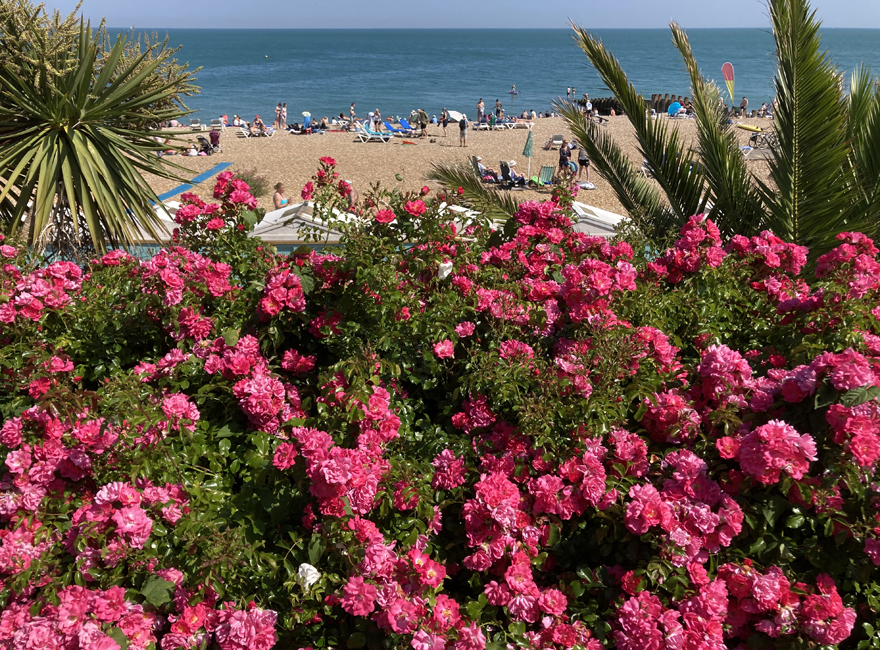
[150,116,773,213]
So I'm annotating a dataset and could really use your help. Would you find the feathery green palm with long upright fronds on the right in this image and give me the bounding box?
[560,0,880,255]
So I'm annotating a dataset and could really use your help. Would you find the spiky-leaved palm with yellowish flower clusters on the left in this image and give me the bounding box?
[0,2,193,256]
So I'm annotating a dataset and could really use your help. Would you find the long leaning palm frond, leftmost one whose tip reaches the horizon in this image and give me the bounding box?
[572,24,707,232]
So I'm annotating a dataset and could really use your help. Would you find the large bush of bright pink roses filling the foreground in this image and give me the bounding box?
[0,159,880,650]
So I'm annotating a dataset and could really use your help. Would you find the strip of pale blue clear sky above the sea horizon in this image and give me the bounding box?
[46,0,880,28]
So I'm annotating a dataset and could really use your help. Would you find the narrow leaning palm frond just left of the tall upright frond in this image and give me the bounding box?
[670,22,764,242]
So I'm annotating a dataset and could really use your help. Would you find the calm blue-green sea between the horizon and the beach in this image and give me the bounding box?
[125,29,880,123]
